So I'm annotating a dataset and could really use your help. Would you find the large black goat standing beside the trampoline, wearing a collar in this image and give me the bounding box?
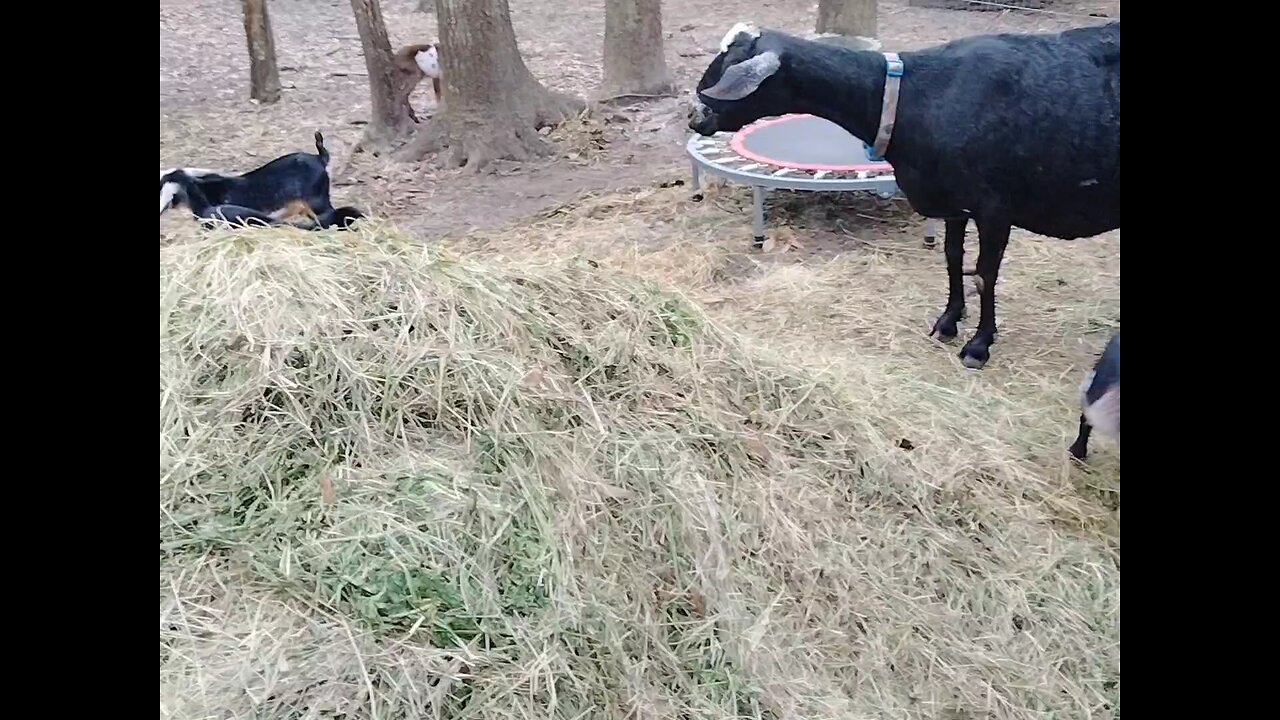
[689,22,1120,368]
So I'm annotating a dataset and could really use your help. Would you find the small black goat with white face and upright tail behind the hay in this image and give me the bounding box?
[160,132,364,229]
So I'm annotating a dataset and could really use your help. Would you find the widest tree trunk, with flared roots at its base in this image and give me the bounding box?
[399,0,584,169]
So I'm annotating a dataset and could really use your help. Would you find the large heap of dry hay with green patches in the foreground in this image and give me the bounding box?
[160,227,1119,719]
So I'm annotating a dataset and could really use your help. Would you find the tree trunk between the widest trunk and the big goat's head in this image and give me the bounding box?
[599,0,672,97]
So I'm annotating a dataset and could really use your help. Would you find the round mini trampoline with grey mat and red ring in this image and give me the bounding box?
[685,114,937,247]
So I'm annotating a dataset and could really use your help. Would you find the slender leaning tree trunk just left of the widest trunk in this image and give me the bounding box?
[351,0,415,149]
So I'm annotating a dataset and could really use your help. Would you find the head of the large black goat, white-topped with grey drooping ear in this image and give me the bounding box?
[689,23,792,135]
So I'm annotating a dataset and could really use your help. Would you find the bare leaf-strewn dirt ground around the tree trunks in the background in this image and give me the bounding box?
[160,0,1120,240]
